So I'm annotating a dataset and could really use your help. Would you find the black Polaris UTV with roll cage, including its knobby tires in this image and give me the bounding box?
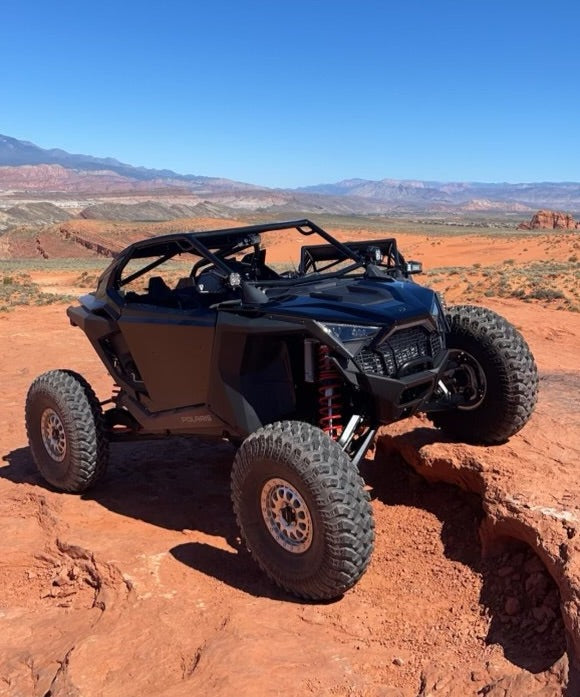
[26,220,538,599]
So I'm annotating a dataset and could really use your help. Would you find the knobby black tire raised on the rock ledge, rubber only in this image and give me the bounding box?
[429,305,538,445]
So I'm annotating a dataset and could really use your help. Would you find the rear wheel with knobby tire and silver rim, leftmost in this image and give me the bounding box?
[26,370,109,492]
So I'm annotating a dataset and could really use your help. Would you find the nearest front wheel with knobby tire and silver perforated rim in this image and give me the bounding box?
[232,421,374,600]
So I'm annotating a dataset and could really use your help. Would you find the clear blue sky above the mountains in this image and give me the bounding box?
[0,0,580,187]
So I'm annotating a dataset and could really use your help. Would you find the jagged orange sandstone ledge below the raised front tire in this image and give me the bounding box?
[376,419,580,670]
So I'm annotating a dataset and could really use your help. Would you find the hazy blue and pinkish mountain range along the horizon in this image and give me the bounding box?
[0,135,580,215]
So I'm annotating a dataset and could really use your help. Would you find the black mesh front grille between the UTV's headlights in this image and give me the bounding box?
[357,327,443,377]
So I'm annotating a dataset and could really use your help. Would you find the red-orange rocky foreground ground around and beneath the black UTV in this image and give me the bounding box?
[0,294,580,697]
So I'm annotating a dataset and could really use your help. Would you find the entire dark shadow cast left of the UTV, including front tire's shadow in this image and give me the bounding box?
[0,437,302,602]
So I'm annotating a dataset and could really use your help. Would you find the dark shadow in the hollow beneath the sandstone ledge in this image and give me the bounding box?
[361,444,566,673]
